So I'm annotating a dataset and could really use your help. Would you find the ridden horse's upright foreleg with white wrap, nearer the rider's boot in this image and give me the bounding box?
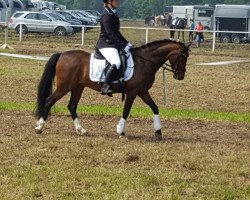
[116,92,136,136]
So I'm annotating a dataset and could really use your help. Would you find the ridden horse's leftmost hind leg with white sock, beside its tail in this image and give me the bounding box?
[35,90,67,133]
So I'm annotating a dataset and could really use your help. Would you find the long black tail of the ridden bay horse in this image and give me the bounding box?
[36,53,61,119]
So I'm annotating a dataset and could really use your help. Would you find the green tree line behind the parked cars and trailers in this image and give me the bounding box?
[50,0,250,19]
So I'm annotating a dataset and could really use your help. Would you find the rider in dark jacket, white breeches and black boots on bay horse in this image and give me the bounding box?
[96,0,132,96]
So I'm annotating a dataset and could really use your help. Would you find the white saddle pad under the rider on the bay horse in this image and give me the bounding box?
[89,53,134,82]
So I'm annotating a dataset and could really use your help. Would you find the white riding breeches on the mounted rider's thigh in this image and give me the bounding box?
[99,47,121,69]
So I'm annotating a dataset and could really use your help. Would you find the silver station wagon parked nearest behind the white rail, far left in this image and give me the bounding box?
[9,11,74,36]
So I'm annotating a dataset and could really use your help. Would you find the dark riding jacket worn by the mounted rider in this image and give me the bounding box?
[96,7,128,50]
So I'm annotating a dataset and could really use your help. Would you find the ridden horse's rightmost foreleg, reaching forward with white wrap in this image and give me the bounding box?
[139,91,162,140]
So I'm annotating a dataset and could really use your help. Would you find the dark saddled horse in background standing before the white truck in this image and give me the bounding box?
[165,14,187,41]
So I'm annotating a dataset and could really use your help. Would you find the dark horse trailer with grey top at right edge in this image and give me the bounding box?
[214,5,250,43]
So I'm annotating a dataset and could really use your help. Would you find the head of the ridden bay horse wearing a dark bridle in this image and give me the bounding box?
[169,43,191,80]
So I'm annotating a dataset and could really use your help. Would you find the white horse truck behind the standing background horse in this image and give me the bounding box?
[165,5,214,30]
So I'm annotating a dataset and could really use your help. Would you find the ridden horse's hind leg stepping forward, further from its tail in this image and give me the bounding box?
[68,85,87,135]
